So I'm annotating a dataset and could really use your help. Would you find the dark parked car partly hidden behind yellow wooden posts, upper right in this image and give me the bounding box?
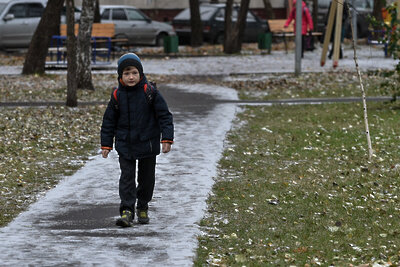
[316,0,374,38]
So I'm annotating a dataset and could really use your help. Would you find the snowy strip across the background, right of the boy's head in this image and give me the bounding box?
[144,46,398,75]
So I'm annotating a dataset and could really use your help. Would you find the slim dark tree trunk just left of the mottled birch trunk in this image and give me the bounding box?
[66,0,78,107]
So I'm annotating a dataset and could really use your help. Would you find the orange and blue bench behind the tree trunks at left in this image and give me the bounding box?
[49,23,128,64]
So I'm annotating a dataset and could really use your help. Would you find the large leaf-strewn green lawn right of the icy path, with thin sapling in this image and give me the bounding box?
[195,103,400,266]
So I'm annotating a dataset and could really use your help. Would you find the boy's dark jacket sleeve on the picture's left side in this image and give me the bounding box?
[100,95,119,150]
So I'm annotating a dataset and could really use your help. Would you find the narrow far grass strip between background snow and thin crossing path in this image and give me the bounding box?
[224,72,396,100]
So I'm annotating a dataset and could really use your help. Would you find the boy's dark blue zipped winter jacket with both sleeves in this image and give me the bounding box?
[101,75,174,159]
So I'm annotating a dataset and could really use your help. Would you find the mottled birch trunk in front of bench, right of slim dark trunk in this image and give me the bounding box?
[76,0,96,90]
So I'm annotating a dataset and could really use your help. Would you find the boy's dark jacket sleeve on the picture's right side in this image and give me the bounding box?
[154,90,174,143]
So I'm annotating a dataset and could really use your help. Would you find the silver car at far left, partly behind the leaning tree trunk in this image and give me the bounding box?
[0,0,80,49]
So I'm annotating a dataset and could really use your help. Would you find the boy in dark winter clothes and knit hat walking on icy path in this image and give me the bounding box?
[101,53,174,227]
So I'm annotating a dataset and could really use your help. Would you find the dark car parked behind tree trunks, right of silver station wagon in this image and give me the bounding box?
[172,4,269,44]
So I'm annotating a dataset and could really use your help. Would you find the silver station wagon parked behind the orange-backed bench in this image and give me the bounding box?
[100,5,175,46]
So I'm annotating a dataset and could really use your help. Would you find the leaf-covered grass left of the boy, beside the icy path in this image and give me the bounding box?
[0,106,105,226]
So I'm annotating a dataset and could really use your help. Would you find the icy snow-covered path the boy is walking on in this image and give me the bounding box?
[0,85,237,266]
